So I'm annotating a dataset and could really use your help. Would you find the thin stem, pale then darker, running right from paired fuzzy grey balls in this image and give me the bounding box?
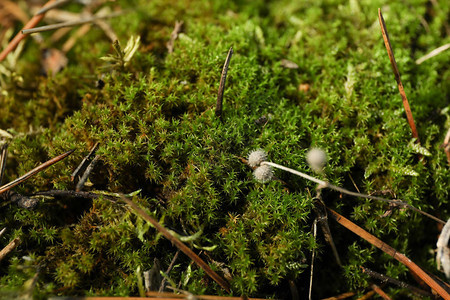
[261,161,445,224]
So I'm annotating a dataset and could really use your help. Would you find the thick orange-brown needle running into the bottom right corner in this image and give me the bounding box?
[327,208,450,299]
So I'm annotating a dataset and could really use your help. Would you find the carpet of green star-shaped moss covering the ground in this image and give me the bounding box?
[0,0,450,298]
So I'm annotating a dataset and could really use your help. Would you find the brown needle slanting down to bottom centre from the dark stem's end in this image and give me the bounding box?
[121,196,230,292]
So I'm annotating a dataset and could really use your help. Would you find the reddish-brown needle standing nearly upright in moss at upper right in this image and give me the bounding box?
[378,9,420,144]
